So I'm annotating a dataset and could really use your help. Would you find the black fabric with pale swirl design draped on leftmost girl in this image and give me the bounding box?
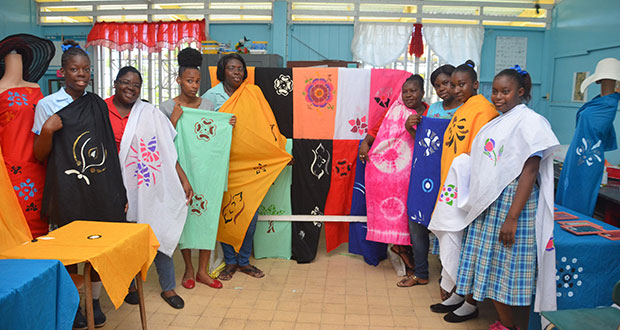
[42,93,127,227]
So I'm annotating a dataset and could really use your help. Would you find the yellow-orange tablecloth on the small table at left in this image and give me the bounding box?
[0,221,159,308]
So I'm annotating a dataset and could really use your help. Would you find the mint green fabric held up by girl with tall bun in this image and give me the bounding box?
[174,107,233,250]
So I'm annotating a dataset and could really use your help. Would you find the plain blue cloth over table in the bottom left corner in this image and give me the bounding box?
[0,259,80,330]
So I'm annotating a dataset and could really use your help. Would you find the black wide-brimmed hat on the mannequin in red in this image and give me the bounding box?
[0,33,56,83]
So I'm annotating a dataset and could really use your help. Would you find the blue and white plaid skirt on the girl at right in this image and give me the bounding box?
[456,178,538,306]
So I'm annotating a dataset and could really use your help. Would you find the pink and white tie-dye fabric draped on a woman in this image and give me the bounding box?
[366,97,424,245]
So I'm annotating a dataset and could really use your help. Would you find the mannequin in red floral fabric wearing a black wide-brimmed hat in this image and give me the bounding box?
[0,34,55,237]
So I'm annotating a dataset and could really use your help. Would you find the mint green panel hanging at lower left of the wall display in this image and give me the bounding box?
[254,139,293,259]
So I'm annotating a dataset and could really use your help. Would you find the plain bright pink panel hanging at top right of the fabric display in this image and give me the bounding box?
[368,69,411,129]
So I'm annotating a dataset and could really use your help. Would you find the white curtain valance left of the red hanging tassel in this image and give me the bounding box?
[351,23,413,66]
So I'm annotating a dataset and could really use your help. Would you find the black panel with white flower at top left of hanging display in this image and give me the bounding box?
[254,68,293,138]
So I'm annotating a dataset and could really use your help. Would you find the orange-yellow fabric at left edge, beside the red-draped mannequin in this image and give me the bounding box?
[0,149,31,251]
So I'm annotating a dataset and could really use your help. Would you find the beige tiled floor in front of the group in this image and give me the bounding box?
[101,235,512,330]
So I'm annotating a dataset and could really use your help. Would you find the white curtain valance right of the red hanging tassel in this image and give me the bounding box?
[422,25,484,68]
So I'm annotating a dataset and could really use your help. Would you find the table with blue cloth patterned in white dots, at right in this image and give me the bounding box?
[528,204,620,329]
